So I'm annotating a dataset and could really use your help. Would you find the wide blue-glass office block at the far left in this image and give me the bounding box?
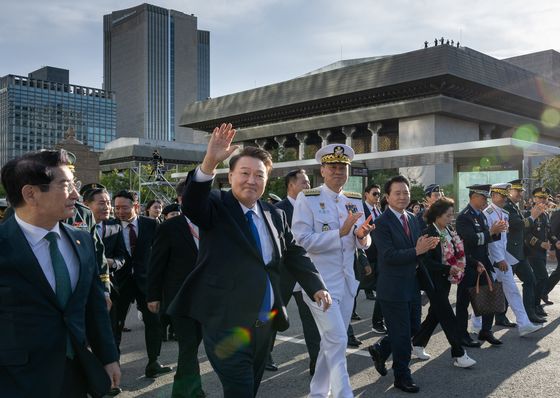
[0,66,116,165]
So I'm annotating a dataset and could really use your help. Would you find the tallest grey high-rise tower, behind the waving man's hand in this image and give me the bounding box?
[103,4,210,143]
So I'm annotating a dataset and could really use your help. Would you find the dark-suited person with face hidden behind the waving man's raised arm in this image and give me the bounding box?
[147,208,205,398]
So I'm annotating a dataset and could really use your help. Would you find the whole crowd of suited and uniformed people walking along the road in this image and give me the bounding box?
[0,124,560,398]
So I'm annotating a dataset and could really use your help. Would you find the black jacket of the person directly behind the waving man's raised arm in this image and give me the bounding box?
[146,215,198,312]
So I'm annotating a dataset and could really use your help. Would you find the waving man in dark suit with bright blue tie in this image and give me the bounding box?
[168,124,331,398]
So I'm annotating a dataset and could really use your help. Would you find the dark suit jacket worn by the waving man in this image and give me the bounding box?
[168,172,325,330]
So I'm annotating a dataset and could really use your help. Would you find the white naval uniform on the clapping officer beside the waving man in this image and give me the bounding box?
[292,185,371,398]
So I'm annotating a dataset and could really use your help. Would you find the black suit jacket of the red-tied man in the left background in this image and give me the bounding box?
[123,216,158,294]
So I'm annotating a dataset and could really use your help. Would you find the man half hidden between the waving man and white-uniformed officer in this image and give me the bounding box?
[267,169,321,376]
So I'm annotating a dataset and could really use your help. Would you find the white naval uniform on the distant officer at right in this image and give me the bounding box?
[473,204,531,328]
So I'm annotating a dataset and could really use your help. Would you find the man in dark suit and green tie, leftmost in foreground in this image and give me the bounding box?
[0,150,120,398]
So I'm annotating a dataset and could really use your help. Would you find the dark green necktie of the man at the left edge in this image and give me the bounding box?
[45,231,74,358]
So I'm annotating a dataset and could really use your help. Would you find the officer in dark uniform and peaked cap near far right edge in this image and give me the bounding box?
[525,187,560,317]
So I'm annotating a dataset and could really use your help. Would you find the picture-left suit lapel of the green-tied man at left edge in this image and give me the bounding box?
[5,217,60,308]
